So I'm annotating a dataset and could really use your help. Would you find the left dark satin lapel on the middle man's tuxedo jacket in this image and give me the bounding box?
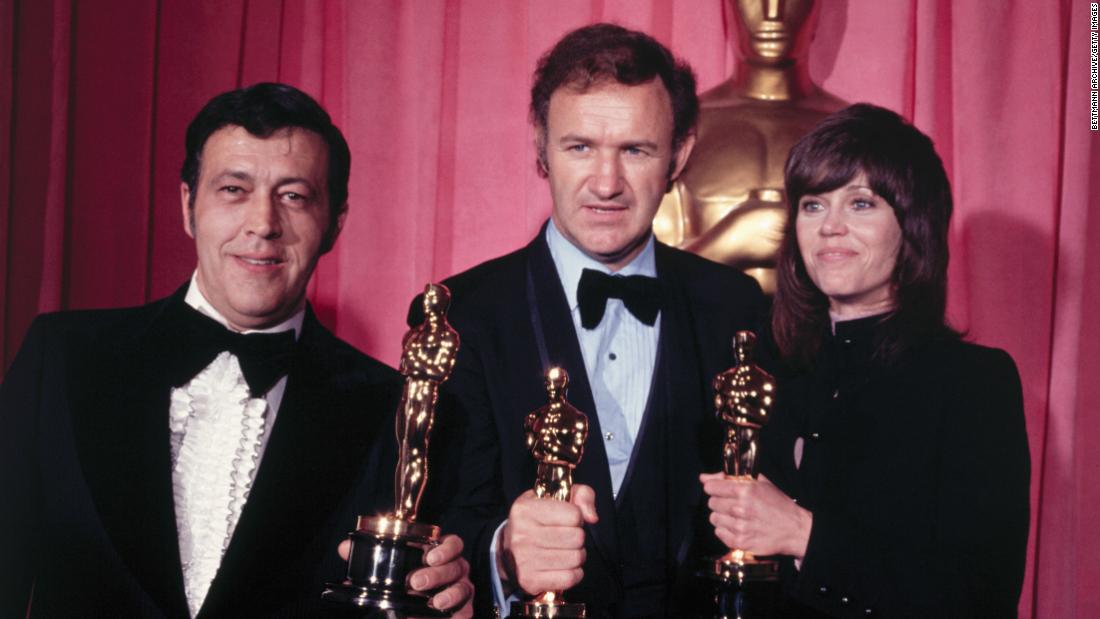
[527,234,618,565]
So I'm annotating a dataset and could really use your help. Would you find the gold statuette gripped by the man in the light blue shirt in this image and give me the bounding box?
[512,367,589,619]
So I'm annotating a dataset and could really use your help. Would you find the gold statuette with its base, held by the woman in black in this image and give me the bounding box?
[705,331,779,619]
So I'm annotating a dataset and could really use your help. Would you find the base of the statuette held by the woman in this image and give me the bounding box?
[702,550,779,619]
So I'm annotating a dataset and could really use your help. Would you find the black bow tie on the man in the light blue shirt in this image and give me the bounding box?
[576,268,661,329]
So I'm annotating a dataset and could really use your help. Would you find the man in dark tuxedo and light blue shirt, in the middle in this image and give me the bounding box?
[410,24,762,617]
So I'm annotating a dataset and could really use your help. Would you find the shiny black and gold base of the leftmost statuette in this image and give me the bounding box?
[321,516,451,617]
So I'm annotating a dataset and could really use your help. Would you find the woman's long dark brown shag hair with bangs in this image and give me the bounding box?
[772,103,958,366]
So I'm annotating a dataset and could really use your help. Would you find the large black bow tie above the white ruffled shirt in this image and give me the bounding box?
[166,303,295,398]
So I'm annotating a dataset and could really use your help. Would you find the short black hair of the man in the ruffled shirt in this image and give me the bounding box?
[179,82,351,252]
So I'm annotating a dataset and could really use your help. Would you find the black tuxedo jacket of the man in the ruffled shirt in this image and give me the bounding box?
[0,286,400,618]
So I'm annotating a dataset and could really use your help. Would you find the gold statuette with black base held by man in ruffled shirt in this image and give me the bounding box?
[321,284,459,617]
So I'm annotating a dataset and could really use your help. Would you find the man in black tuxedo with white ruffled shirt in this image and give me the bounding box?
[0,84,472,617]
